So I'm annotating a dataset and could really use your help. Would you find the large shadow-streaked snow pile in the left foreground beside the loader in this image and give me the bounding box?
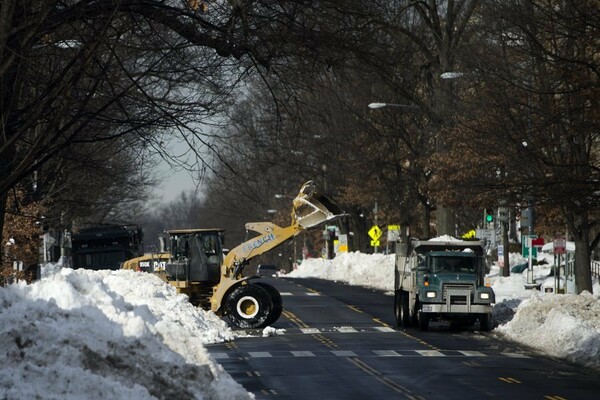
[0,269,252,400]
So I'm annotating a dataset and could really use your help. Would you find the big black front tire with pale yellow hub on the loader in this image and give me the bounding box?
[225,284,273,329]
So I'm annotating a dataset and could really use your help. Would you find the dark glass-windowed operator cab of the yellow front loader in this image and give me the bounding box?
[166,229,224,282]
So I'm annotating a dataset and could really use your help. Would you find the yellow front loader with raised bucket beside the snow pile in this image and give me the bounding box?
[123,181,343,328]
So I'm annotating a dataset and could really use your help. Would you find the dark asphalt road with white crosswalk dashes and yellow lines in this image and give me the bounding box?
[207,278,600,400]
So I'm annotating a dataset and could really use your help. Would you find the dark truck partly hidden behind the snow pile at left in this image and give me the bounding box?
[71,225,143,270]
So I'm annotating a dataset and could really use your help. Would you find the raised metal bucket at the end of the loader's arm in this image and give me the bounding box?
[292,181,345,229]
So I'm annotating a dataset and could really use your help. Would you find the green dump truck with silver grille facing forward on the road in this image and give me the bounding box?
[394,238,495,331]
